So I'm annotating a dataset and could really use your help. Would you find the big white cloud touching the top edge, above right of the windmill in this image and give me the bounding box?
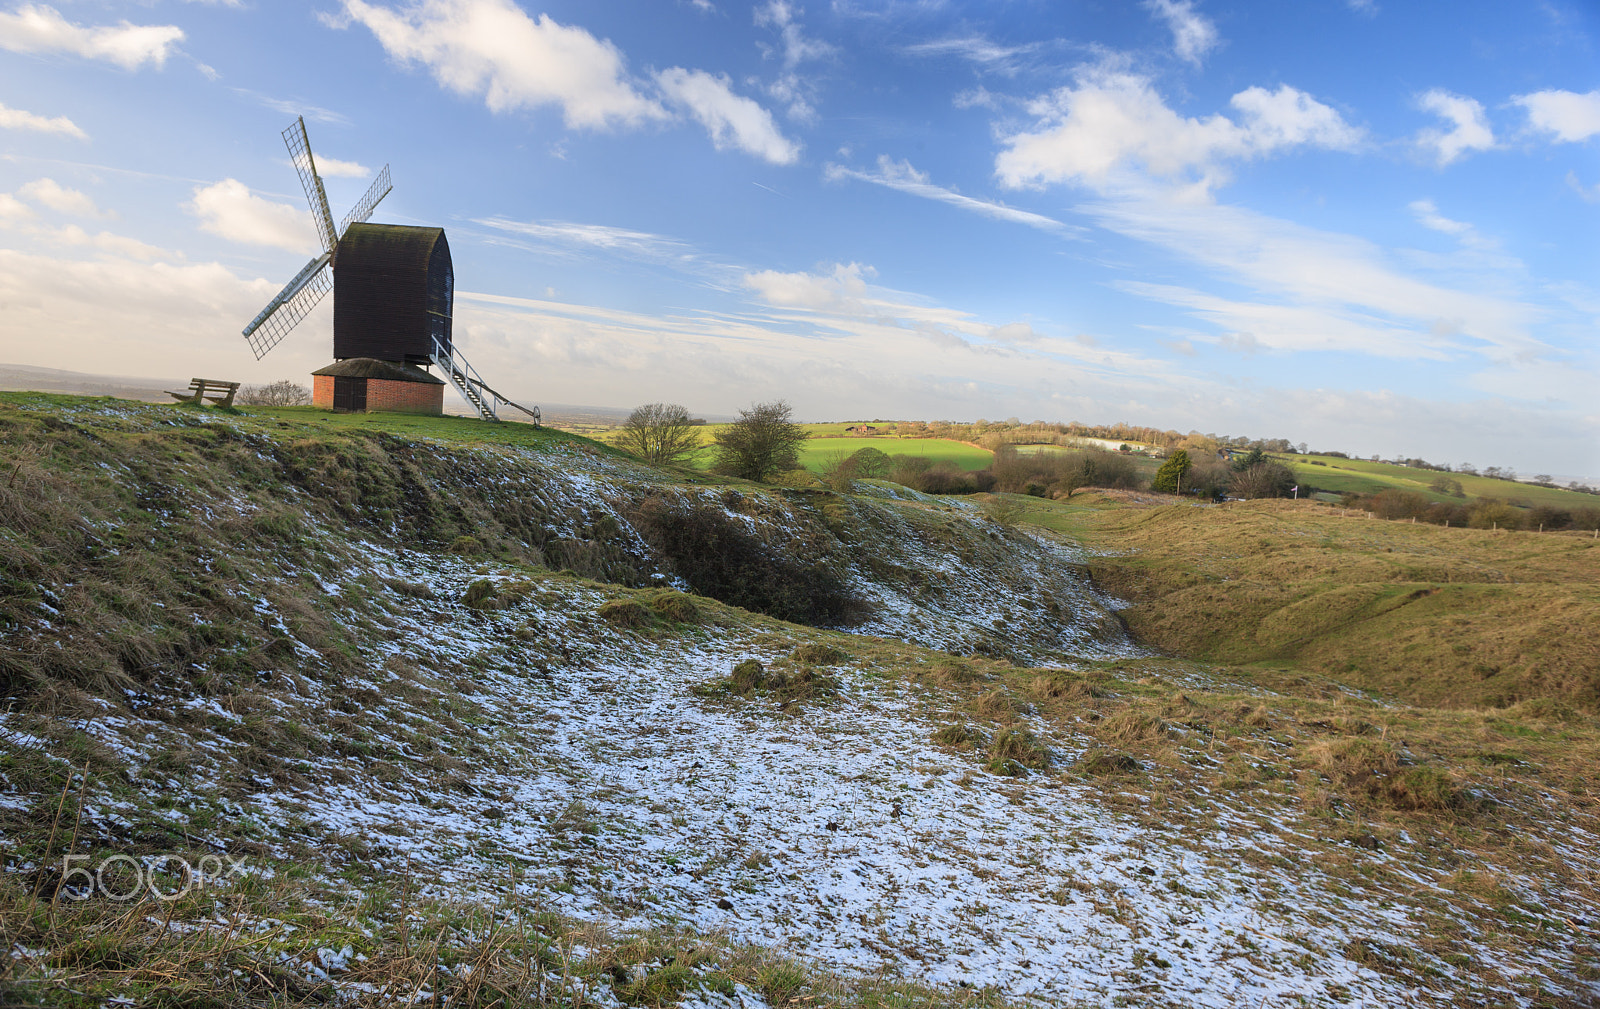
[344,0,666,130]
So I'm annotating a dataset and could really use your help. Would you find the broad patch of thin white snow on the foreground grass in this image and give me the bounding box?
[43,560,1515,1007]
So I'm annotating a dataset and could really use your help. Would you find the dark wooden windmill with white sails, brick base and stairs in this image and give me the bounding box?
[236,118,539,424]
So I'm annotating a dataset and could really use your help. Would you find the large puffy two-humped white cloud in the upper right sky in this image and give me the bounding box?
[995,67,1362,192]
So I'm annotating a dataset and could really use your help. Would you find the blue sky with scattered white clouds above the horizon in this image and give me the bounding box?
[0,0,1600,477]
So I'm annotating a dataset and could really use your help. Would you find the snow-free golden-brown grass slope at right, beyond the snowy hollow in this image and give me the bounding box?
[1029,494,1600,712]
